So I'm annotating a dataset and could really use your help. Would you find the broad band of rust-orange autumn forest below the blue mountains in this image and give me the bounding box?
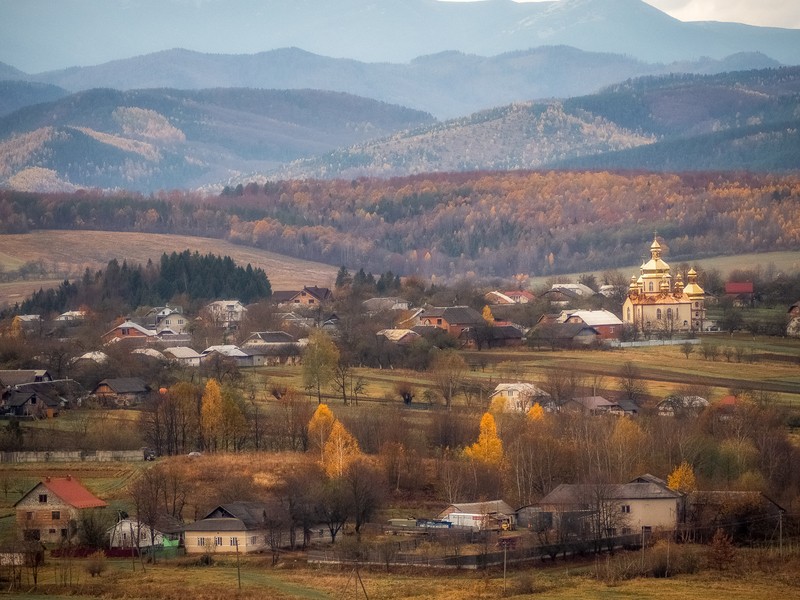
[0,171,800,278]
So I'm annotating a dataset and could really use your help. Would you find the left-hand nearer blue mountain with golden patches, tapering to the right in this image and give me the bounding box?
[0,88,434,191]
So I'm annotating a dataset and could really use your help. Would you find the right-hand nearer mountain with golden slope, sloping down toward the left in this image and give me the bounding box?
[271,67,800,178]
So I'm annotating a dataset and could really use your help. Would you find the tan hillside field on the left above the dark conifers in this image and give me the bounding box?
[0,231,338,306]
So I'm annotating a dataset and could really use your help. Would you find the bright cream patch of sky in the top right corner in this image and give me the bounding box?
[445,0,800,29]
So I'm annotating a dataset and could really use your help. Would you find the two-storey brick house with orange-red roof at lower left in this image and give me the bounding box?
[14,476,107,543]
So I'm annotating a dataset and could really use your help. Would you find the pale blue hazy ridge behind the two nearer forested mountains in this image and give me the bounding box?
[0,46,780,119]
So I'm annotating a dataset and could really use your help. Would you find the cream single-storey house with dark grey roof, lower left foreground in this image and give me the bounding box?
[183,502,275,554]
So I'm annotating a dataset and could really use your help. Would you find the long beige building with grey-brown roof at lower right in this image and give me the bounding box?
[539,475,681,537]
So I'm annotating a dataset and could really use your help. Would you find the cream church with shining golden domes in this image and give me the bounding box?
[622,238,705,335]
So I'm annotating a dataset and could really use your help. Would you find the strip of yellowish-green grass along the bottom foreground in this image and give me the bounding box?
[6,550,800,600]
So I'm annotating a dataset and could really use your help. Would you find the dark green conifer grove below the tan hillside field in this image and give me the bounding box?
[14,250,272,314]
